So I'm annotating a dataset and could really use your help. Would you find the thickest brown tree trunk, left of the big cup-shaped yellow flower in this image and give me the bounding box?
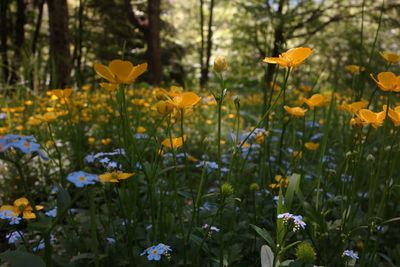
[47,0,71,87]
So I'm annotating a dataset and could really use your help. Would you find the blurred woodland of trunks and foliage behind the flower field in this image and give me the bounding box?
[0,0,400,92]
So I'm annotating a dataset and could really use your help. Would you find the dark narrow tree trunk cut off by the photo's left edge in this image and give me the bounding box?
[0,0,10,82]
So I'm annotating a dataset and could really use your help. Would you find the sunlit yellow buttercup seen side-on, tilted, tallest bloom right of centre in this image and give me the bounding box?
[264,47,312,68]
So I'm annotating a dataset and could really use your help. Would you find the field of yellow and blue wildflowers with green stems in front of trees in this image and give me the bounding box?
[0,47,400,267]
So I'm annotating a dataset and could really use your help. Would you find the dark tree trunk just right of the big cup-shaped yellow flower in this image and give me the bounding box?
[145,0,162,84]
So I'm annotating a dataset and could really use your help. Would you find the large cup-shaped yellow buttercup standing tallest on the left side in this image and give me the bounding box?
[94,59,147,84]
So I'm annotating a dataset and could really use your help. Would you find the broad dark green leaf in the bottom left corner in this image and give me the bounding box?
[0,250,46,267]
